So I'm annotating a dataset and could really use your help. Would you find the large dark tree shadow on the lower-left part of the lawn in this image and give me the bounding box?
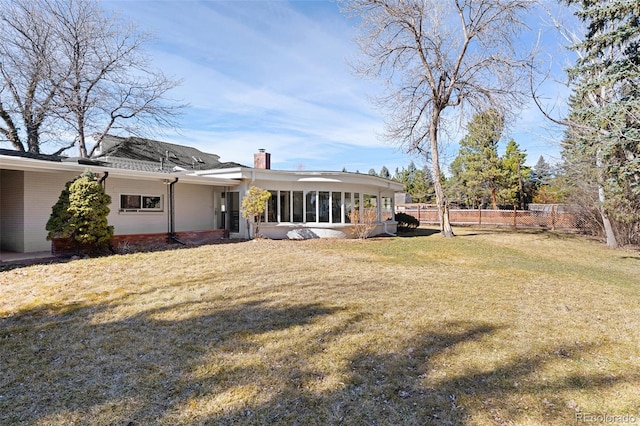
[0,302,336,425]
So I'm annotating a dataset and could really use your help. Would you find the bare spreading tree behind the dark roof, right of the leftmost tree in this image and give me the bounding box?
[50,0,184,157]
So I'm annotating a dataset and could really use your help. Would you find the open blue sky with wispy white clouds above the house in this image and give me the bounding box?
[104,0,568,174]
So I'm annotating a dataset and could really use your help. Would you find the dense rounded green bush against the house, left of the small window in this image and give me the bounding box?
[46,171,113,252]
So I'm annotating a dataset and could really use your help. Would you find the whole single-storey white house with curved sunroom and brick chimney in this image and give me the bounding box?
[0,136,402,253]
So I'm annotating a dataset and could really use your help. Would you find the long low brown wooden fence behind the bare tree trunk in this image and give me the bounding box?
[396,204,579,230]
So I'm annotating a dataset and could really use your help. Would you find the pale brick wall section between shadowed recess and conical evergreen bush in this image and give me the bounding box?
[23,171,79,253]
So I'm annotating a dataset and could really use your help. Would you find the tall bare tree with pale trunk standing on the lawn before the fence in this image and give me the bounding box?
[343,0,533,237]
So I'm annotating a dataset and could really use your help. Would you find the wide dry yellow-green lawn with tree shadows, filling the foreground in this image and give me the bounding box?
[0,228,640,425]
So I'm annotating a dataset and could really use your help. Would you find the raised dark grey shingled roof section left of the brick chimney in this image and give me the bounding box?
[94,135,245,172]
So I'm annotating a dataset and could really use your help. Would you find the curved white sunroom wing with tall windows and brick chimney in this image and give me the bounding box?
[196,152,403,239]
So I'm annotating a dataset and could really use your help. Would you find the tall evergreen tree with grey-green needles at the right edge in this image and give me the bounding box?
[563,0,640,247]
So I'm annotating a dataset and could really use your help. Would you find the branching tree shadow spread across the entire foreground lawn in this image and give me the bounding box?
[0,301,640,425]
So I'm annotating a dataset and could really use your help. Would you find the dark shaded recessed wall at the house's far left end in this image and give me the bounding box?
[0,170,24,253]
